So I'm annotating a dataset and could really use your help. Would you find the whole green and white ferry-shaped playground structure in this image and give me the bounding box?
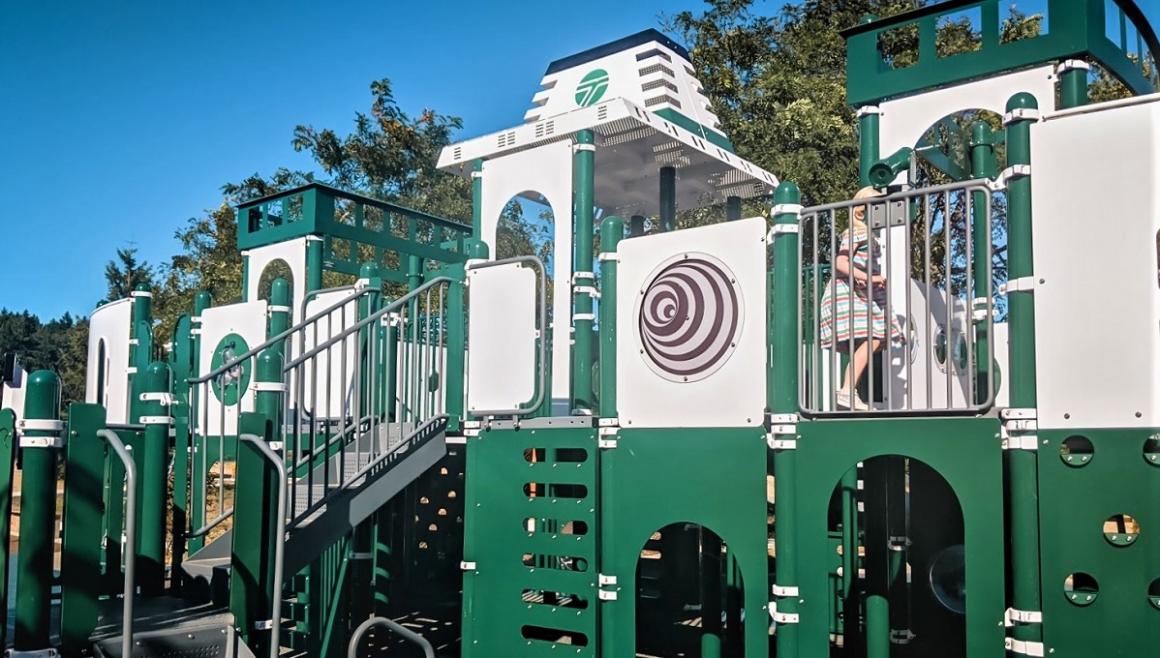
[0,0,1160,658]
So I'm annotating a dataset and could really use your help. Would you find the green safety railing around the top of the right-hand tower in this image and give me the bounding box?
[842,0,1160,106]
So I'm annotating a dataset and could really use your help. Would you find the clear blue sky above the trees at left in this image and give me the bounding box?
[0,0,719,318]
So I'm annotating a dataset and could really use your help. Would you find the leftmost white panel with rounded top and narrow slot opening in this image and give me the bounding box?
[85,299,133,424]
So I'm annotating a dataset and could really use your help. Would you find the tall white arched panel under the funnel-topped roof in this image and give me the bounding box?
[479,142,572,415]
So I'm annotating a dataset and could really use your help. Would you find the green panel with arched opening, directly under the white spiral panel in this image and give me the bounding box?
[598,428,769,658]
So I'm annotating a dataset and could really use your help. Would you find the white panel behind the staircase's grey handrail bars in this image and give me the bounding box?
[290,290,358,419]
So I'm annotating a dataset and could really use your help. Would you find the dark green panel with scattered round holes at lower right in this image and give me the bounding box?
[1039,428,1160,658]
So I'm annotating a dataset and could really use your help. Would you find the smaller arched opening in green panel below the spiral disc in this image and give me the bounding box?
[636,523,745,658]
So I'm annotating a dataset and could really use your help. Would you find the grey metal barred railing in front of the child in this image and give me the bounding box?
[798,180,1001,415]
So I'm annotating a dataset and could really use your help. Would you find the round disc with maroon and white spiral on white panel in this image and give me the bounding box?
[637,253,745,382]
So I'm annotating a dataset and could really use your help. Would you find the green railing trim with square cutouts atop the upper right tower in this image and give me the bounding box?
[842,0,1160,106]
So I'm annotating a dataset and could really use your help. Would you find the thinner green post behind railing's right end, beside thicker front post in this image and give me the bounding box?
[970,121,999,403]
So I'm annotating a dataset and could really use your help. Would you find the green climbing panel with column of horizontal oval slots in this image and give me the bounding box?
[463,428,601,658]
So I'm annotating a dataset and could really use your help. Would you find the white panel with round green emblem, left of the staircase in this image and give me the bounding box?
[196,301,267,436]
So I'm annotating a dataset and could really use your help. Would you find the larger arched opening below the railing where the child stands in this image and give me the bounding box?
[827,455,967,658]
